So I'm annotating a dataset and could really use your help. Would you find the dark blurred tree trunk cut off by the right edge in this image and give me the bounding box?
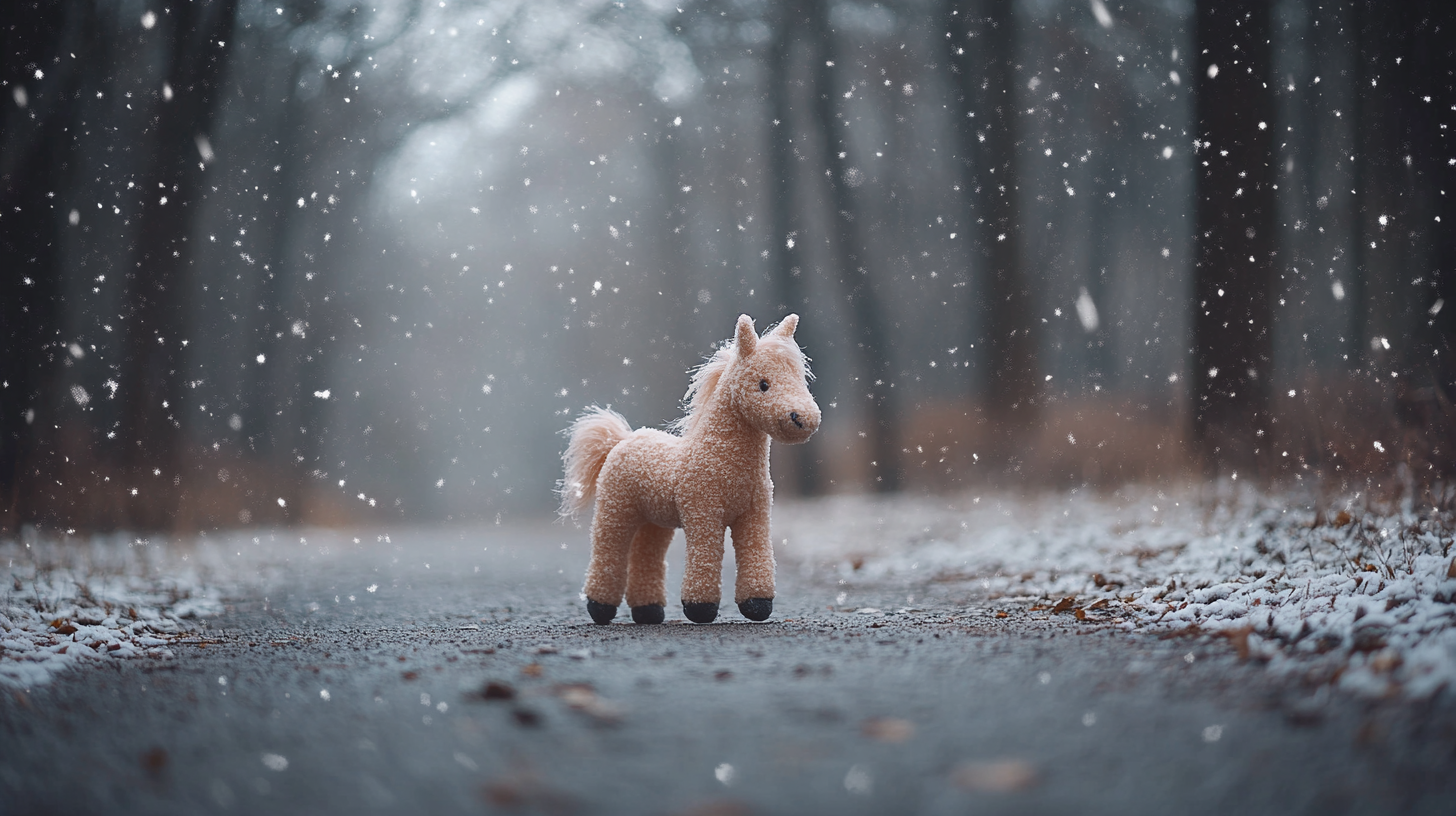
[1351,0,1456,472]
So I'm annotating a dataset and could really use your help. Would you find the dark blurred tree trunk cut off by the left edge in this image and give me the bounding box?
[0,3,111,535]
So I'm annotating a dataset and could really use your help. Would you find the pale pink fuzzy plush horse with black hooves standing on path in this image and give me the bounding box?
[561,315,820,624]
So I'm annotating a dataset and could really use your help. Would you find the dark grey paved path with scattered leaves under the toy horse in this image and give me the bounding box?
[0,526,1456,815]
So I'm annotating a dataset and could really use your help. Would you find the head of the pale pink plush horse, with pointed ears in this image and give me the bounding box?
[719,315,820,444]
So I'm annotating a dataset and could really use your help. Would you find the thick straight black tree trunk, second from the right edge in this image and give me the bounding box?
[1194,0,1275,472]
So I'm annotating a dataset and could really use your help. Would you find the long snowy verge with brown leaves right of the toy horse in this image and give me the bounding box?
[773,484,1456,698]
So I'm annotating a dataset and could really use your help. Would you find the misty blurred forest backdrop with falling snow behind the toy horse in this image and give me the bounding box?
[0,0,1456,535]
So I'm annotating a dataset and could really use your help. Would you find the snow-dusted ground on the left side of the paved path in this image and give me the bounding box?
[0,536,232,688]
